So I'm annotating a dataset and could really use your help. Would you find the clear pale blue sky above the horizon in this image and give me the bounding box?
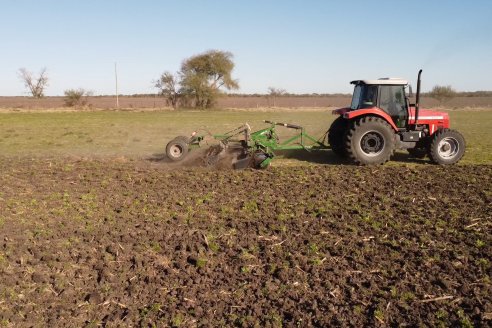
[0,0,492,96]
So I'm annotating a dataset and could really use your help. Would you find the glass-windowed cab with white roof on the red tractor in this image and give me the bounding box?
[350,78,409,128]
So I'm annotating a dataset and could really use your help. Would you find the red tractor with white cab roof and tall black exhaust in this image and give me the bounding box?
[328,70,465,165]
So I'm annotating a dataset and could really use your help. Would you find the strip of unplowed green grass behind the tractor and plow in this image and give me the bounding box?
[0,110,492,164]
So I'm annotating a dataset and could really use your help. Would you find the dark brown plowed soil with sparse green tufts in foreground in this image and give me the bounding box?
[0,158,492,327]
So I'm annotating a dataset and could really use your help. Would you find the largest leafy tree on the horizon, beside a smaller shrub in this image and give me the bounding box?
[179,50,239,108]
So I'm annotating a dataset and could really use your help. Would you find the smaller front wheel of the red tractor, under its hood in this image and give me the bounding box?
[429,129,466,165]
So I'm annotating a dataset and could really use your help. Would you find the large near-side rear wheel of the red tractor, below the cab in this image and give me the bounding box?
[345,116,395,165]
